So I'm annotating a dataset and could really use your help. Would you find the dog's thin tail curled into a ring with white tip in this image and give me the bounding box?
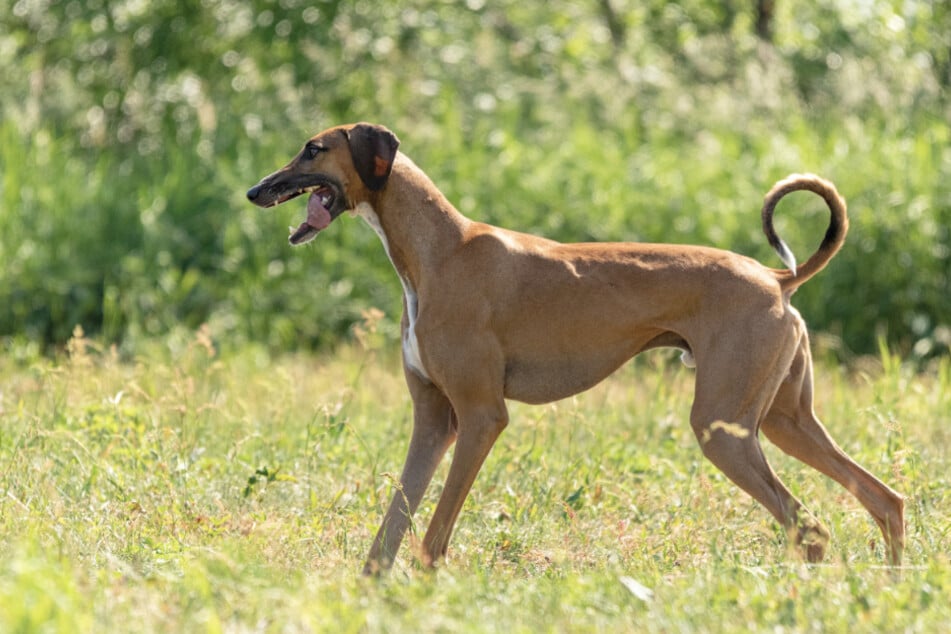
[763,174,849,293]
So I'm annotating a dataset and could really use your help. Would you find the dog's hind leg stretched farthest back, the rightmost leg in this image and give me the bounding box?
[762,337,905,565]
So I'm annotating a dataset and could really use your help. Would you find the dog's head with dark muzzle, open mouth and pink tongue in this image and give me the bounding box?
[248,123,400,246]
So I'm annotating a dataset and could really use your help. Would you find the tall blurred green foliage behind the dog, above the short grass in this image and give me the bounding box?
[0,0,951,359]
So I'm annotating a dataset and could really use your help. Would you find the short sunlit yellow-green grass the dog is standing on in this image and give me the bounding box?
[0,330,951,632]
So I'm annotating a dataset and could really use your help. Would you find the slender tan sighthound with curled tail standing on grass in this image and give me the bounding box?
[247,123,905,574]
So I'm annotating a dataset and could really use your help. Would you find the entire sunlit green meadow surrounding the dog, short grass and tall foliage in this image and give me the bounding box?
[0,0,951,632]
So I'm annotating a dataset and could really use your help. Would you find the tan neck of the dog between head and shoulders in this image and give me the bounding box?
[355,153,472,288]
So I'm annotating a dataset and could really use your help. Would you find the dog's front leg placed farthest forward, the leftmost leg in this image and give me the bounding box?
[363,371,456,575]
